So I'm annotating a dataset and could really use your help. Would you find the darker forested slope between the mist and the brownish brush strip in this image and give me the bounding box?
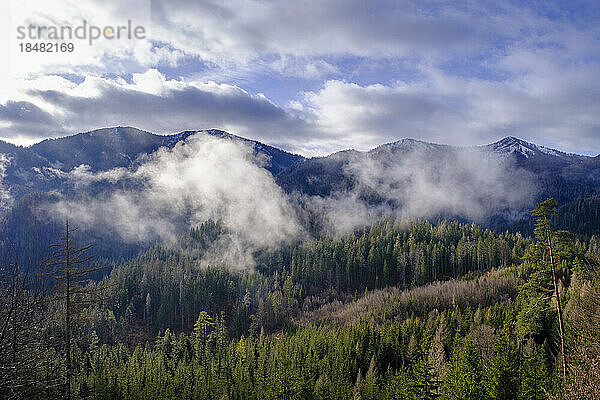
[107,219,530,335]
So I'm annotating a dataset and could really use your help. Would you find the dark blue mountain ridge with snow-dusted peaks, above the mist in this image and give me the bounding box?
[0,127,600,208]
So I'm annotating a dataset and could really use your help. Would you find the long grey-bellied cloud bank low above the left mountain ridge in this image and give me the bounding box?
[0,71,316,152]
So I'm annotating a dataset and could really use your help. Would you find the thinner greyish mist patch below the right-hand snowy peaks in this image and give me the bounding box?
[302,142,538,236]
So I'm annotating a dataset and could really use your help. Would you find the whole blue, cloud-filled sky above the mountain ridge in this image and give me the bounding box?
[0,0,600,156]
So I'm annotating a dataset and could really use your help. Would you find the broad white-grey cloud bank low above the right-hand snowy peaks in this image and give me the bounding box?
[303,54,600,152]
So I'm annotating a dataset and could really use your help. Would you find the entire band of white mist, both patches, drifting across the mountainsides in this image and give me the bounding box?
[44,133,537,268]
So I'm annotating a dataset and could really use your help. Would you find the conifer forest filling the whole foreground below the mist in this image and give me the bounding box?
[0,203,600,399]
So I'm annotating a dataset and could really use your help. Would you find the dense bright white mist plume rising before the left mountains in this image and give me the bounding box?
[50,133,302,268]
